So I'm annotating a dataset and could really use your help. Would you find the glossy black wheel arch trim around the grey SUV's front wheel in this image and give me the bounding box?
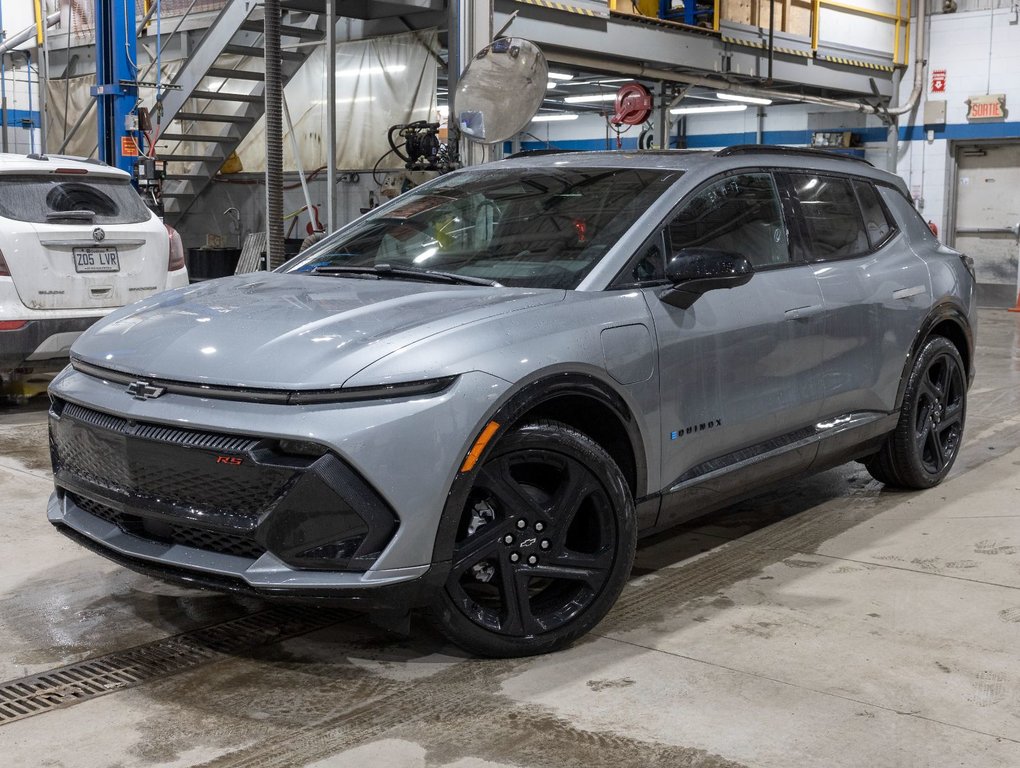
[432,373,648,567]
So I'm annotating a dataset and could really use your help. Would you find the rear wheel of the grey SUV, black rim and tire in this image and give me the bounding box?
[865,336,967,491]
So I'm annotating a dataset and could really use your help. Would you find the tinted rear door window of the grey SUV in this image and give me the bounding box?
[791,173,871,261]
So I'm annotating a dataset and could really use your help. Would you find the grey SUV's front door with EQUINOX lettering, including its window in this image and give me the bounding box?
[633,170,823,522]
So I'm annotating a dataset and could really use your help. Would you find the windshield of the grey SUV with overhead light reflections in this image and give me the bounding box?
[283,167,680,289]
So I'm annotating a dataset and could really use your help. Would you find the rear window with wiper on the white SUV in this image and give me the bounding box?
[0,174,150,224]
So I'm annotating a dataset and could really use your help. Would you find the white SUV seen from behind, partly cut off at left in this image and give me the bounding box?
[0,154,188,376]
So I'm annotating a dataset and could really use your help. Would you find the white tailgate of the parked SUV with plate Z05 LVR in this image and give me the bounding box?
[0,168,168,309]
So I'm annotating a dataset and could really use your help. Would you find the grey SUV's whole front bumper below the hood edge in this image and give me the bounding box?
[49,369,506,607]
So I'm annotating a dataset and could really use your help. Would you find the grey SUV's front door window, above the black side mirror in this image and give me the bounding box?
[669,173,789,267]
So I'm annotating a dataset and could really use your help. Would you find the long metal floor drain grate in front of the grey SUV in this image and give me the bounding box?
[0,608,350,725]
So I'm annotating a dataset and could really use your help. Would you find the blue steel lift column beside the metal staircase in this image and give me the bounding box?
[92,0,141,173]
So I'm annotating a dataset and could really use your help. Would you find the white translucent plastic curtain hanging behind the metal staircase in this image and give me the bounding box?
[238,30,439,172]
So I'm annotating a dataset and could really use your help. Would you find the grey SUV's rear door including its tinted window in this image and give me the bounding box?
[784,171,931,419]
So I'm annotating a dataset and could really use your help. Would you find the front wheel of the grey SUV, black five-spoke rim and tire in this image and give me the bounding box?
[429,421,638,658]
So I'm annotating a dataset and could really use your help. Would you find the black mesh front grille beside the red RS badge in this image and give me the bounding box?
[51,403,296,518]
